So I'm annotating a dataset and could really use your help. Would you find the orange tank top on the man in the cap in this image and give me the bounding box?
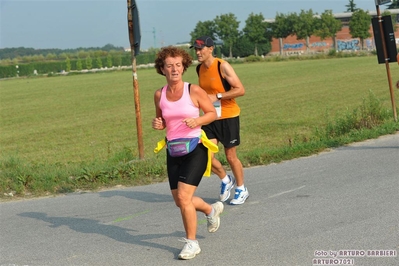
[198,58,240,119]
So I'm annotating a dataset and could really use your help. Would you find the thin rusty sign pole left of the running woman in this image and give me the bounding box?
[127,0,144,159]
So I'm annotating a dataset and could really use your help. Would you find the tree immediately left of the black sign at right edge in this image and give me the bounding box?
[349,9,371,50]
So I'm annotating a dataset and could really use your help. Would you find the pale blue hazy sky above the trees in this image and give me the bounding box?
[0,0,386,49]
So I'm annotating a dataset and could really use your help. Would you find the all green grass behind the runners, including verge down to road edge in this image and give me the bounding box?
[0,56,399,195]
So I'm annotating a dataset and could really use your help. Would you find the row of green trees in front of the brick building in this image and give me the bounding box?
[190,0,399,57]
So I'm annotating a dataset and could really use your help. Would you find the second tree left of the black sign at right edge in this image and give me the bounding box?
[315,10,342,50]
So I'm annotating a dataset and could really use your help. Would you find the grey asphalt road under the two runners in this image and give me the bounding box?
[0,133,399,266]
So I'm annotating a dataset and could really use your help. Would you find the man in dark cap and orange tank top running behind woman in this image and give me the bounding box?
[190,36,249,205]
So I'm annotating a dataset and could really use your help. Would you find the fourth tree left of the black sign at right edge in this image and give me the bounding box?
[272,13,297,55]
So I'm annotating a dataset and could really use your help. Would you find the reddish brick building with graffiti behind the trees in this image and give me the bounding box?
[266,9,399,55]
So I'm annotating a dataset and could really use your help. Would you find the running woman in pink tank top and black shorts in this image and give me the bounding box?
[152,46,224,260]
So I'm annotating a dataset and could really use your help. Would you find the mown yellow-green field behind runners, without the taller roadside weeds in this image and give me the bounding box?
[0,56,399,197]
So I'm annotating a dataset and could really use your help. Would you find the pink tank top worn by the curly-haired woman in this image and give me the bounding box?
[159,82,201,140]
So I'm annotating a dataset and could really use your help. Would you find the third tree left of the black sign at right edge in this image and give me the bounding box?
[294,9,316,52]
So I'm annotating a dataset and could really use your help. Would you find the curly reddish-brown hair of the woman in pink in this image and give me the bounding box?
[155,45,193,76]
